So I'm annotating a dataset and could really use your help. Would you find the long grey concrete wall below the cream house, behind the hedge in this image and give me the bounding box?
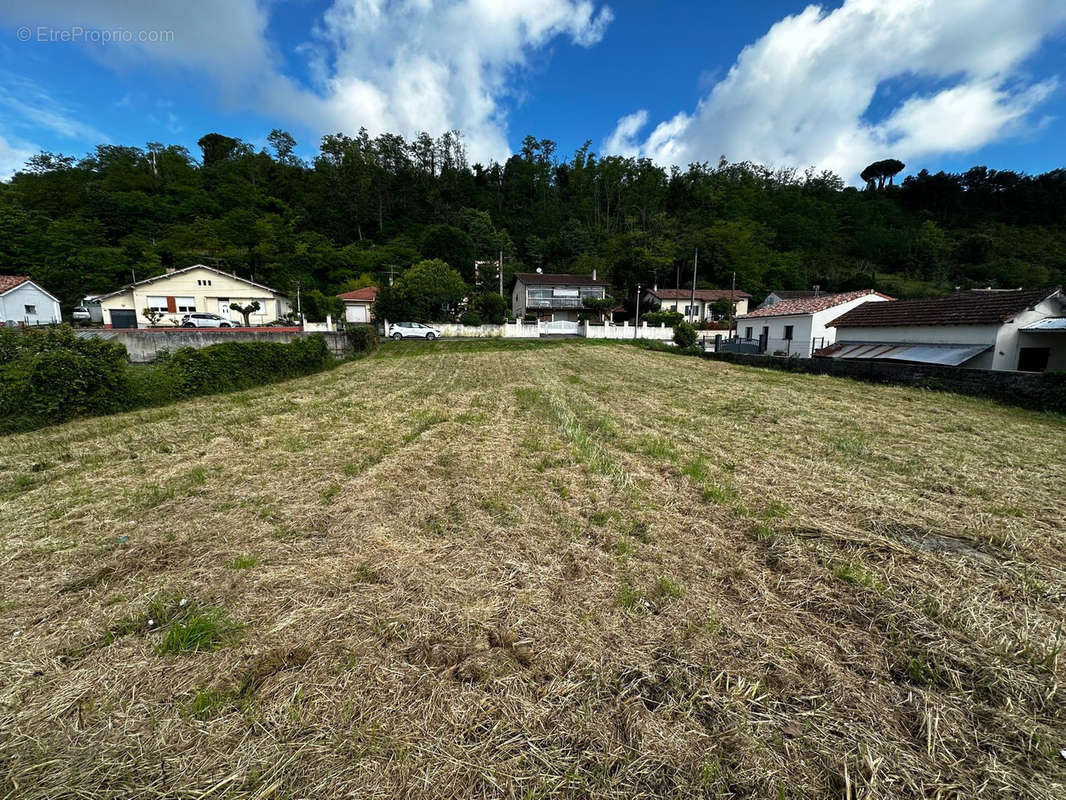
[75,327,349,364]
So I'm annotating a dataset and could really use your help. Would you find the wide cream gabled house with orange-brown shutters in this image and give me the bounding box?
[85,263,289,327]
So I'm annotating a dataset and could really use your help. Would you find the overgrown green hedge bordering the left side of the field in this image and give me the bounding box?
[0,326,332,433]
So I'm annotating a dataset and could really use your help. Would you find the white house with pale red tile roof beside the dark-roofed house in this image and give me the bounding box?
[737,289,891,356]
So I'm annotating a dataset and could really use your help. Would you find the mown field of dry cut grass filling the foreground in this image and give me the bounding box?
[0,342,1066,800]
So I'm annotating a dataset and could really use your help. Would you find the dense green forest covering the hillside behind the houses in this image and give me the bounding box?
[0,130,1066,306]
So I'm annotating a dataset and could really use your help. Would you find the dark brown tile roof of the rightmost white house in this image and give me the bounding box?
[828,288,1059,327]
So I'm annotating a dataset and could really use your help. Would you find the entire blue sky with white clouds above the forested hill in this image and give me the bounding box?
[0,0,1066,181]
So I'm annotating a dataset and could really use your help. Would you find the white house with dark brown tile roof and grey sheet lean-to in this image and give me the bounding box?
[819,288,1066,372]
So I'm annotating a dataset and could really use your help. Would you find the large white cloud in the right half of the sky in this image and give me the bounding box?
[607,0,1066,178]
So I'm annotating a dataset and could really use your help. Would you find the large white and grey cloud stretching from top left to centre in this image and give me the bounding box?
[0,0,612,160]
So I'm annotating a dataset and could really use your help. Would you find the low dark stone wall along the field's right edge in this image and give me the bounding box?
[704,352,1066,414]
